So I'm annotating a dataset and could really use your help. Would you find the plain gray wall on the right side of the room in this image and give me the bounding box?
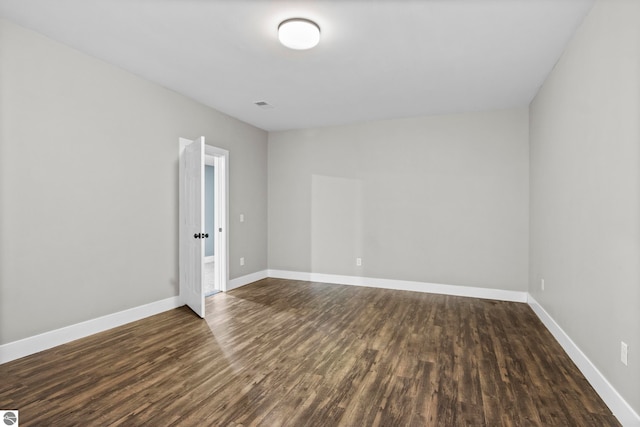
[529,0,640,412]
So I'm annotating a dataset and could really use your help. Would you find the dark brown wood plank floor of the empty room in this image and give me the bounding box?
[0,279,619,427]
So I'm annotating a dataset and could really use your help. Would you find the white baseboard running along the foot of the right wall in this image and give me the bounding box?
[527,294,640,427]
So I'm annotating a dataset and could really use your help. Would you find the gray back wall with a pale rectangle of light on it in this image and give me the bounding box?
[268,109,529,291]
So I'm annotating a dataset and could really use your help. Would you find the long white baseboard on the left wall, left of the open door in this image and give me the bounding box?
[0,297,183,364]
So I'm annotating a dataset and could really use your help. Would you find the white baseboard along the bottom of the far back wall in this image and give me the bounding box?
[268,270,527,302]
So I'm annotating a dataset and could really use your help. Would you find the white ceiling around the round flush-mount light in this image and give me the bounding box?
[0,0,594,130]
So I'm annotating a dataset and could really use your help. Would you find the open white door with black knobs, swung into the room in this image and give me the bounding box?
[179,136,205,317]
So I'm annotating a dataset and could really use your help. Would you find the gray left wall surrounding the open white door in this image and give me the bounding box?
[0,21,267,344]
